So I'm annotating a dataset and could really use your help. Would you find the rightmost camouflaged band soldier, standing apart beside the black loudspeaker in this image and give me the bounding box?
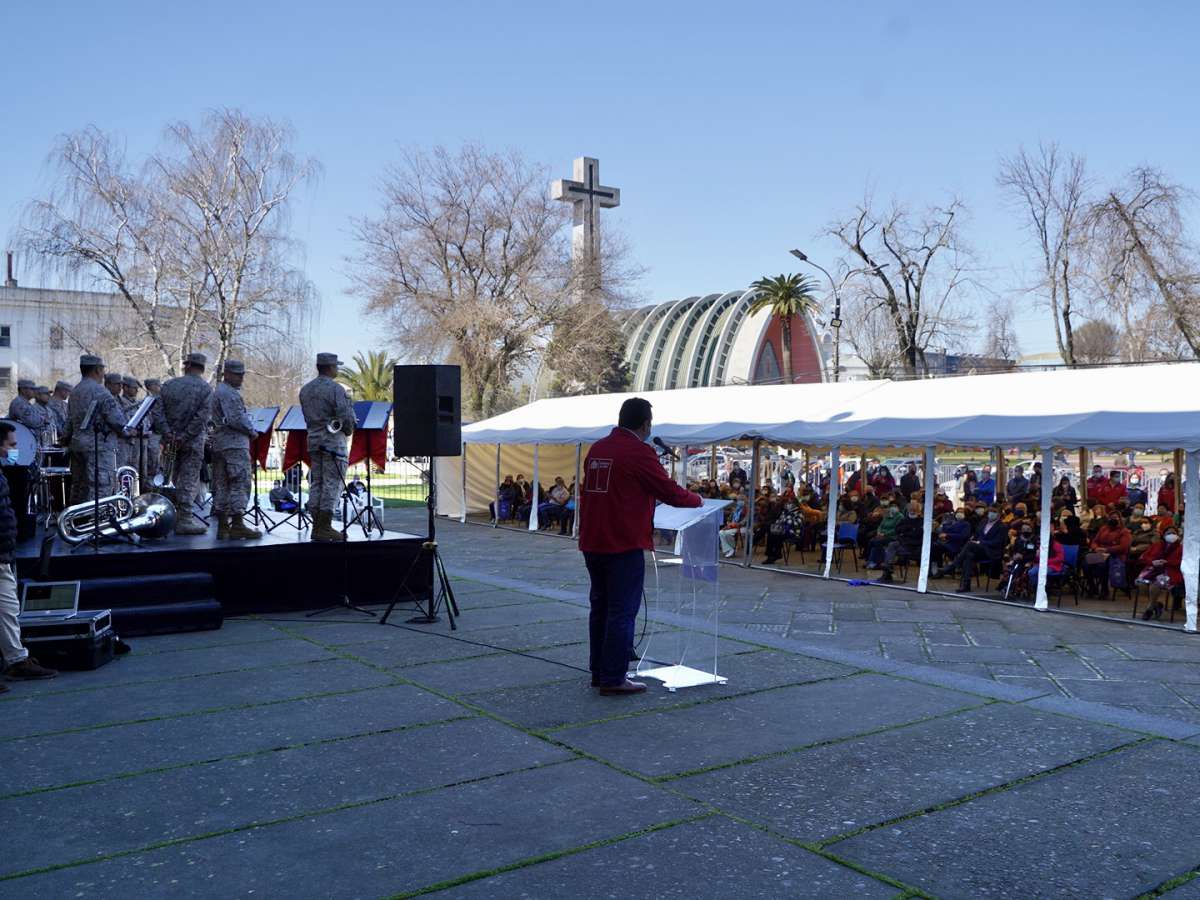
[300,353,354,541]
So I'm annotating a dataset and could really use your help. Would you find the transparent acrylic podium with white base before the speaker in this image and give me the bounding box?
[635,500,730,691]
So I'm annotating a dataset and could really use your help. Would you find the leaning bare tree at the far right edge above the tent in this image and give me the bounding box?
[1088,167,1200,359]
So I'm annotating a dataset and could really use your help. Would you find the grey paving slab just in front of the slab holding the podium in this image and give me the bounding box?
[554,674,983,776]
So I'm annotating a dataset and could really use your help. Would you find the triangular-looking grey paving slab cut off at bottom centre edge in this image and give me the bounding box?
[431,816,896,900]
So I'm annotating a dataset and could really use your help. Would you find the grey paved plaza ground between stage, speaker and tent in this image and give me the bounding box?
[7,511,1200,898]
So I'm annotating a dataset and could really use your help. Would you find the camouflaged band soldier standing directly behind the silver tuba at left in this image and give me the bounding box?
[64,354,125,504]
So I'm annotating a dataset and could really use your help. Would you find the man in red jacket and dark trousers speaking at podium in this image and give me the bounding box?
[578,397,702,695]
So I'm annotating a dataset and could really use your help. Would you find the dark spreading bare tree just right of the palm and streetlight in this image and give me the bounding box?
[828,198,970,378]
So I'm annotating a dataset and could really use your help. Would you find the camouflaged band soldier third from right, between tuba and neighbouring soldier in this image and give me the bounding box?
[161,353,212,534]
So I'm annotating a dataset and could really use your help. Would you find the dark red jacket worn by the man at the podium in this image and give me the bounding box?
[580,427,702,553]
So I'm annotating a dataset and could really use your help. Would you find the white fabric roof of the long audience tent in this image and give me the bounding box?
[463,362,1200,450]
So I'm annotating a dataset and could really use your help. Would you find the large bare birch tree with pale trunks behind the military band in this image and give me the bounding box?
[18,110,318,374]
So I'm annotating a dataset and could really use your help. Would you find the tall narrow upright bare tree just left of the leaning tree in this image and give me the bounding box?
[996,143,1088,366]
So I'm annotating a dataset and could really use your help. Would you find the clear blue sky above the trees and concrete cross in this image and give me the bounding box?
[0,0,1200,355]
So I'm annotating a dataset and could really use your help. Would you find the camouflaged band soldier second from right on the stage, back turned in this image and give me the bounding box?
[212,360,263,540]
